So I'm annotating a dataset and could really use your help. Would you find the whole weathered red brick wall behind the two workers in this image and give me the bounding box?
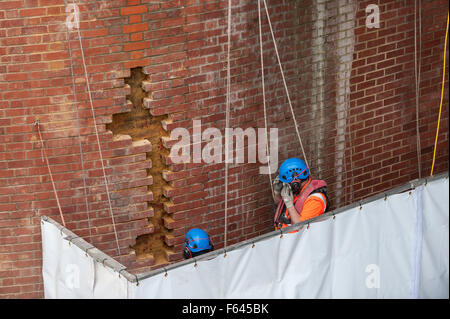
[0,0,448,298]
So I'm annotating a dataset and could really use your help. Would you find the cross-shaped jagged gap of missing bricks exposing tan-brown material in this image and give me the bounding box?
[107,67,172,267]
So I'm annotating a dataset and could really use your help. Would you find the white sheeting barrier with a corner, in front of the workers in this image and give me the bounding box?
[42,174,449,299]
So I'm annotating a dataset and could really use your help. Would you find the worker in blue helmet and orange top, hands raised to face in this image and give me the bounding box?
[273,158,329,229]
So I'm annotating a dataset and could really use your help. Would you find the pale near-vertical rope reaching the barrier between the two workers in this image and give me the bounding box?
[224,0,231,248]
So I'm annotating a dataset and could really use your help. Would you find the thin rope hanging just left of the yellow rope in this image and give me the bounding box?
[414,0,422,178]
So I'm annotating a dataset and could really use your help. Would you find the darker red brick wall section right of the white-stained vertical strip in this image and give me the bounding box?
[349,1,448,200]
